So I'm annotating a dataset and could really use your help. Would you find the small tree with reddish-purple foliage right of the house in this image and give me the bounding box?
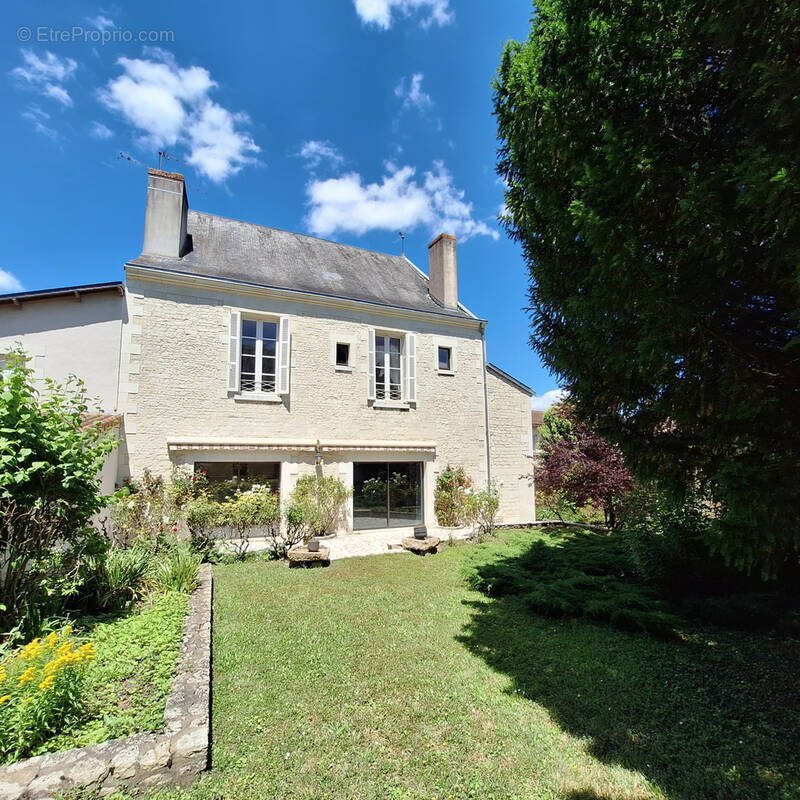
[536,403,633,528]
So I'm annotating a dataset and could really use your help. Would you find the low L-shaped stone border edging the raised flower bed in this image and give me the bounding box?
[0,564,213,800]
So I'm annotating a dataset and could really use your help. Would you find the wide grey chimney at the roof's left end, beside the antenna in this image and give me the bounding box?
[142,169,190,258]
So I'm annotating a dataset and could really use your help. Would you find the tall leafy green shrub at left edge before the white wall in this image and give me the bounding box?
[0,349,117,628]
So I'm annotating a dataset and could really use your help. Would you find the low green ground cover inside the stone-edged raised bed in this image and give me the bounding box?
[37,592,188,752]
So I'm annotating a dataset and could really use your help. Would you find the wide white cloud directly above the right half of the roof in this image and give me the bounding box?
[306,161,499,239]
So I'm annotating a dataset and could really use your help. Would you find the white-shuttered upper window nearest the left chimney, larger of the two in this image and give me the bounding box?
[228,310,291,395]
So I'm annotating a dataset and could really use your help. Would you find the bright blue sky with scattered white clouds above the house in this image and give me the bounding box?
[0,0,557,405]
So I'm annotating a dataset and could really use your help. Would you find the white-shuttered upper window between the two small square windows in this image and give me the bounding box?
[368,328,417,403]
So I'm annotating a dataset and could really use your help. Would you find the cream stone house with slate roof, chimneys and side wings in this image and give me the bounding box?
[0,169,534,530]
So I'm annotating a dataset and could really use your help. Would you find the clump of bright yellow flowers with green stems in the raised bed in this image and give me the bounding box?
[0,626,94,762]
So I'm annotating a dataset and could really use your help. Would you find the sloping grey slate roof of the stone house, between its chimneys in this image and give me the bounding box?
[128,210,472,318]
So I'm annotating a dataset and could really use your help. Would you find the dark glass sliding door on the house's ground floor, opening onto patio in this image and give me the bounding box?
[353,462,422,530]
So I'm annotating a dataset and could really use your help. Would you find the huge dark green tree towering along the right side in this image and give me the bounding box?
[495,0,800,573]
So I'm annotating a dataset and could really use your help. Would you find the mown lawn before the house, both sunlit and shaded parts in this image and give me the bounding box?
[148,531,800,800]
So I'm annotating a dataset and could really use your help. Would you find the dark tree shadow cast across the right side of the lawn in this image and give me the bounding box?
[459,544,800,800]
